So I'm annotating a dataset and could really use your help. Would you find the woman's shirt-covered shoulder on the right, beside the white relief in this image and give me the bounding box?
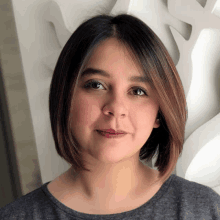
[169,175,220,219]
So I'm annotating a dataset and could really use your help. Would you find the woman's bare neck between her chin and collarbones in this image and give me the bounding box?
[70,160,156,203]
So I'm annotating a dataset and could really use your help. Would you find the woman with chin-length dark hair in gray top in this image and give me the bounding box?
[0,14,220,220]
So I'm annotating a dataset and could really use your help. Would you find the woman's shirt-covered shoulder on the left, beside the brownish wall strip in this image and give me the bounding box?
[0,182,50,220]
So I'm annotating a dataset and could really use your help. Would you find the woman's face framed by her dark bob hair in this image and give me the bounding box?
[71,38,159,165]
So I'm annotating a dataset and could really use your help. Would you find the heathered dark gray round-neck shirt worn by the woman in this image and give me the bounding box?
[0,174,220,220]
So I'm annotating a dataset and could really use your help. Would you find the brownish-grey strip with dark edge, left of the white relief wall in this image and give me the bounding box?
[0,0,42,207]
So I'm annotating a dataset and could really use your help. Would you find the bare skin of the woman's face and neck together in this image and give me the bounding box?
[49,38,160,210]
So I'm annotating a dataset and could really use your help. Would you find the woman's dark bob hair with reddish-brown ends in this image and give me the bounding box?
[49,13,188,186]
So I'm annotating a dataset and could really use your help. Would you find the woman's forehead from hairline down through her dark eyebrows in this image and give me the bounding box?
[80,39,156,86]
